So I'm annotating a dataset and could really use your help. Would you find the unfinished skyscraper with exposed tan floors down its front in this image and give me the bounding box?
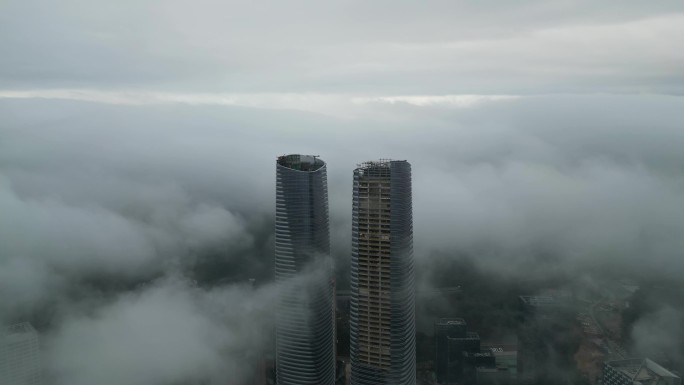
[350,160,416,385]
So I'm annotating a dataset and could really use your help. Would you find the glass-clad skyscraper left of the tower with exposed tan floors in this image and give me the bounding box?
[275,155,335,385]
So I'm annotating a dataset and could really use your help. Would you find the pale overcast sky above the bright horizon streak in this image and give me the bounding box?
[0,0,684,94]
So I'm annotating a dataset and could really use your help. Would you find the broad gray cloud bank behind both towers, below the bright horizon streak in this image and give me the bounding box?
[1,96,684,282]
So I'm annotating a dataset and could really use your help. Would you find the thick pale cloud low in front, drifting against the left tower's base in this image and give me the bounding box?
[44,277,276,385]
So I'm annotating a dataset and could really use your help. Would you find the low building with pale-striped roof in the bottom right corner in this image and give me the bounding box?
[603,358,682,385]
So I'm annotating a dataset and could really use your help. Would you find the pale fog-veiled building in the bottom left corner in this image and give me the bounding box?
[0,322,42,385]
